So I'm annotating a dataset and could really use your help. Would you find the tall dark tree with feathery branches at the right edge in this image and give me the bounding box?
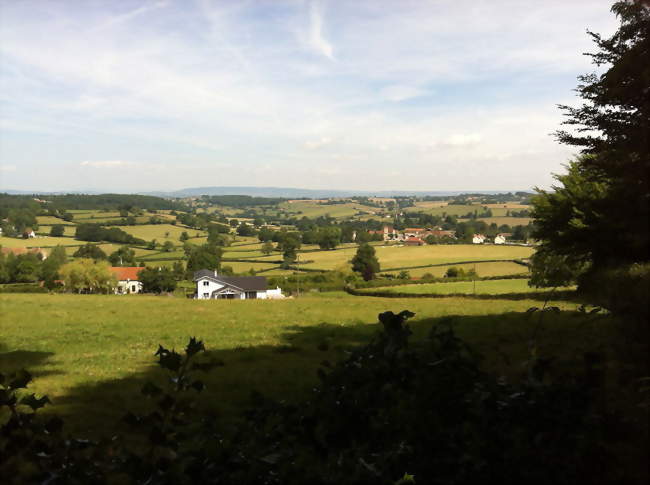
[532,1,650,284]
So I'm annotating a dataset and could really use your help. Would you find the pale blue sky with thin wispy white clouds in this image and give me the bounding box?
[0,0,617,192]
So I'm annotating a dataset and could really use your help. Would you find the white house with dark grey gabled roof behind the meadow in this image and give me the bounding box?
[194,269,284,300]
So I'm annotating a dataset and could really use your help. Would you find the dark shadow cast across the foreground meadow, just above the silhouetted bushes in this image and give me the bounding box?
[39,306,611,436]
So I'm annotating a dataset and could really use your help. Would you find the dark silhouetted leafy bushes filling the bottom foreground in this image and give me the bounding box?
[0,308,638,484]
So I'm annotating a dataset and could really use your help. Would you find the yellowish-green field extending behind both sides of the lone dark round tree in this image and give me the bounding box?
[300,244,534,271]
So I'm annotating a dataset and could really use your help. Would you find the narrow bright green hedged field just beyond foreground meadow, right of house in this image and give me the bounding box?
[362,279,566,295]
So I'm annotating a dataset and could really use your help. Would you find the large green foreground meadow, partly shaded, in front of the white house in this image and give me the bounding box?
[0,293,584,434]
